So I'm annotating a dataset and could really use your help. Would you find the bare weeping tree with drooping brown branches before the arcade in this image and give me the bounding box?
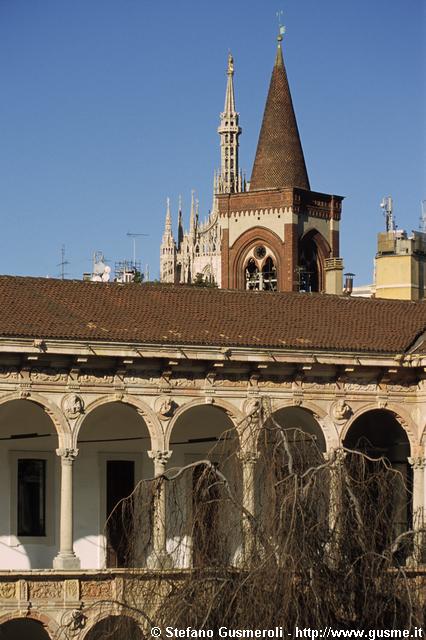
[61,403,424,640]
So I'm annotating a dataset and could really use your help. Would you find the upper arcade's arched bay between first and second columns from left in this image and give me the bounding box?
[73,393,163,568]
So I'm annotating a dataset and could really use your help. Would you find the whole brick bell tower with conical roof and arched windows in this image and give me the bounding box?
[216,29,343,293]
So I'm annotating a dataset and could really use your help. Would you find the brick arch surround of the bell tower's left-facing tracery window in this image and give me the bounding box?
[230,226,284,291]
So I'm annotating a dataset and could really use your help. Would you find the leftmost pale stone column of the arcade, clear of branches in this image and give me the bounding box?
[53,449,80,569]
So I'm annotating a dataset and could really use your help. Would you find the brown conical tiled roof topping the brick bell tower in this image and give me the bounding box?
[250,42,310,191]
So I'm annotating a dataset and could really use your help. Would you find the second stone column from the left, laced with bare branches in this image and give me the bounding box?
[147,450,172,568]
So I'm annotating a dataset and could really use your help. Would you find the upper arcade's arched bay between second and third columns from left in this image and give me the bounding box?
[166,398,243,567]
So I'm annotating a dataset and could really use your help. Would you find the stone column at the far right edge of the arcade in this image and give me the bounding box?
[408,447,426,563]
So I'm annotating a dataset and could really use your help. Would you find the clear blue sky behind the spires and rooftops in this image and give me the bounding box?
[0,0,426,284]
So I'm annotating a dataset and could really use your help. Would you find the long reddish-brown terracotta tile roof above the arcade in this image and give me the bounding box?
[0,276,426,353]
